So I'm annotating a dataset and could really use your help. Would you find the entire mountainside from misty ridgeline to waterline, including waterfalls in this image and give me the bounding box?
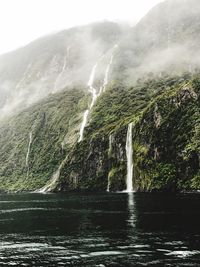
[0,0,200,192]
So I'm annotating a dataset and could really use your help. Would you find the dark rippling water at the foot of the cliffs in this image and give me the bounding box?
[0,194,200,267]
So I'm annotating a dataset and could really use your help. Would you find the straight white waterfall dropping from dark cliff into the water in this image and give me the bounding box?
[126,123,133,192]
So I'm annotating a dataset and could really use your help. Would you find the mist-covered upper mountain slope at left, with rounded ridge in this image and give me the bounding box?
[0,22,123,118]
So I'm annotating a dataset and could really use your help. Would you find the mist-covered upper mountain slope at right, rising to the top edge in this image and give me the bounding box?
[116,0,200,83]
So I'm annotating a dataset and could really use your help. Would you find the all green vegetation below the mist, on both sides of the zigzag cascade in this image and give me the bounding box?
[0,74,200,194]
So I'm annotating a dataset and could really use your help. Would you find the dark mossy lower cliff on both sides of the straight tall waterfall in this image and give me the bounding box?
[56,76,200,194]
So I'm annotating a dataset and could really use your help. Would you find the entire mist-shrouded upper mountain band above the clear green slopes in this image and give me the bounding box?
[0,0,200,119]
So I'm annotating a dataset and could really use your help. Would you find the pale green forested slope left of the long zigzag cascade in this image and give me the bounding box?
[0,89,87,191]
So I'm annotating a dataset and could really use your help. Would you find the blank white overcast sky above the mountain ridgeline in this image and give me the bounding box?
[0,0,162,54]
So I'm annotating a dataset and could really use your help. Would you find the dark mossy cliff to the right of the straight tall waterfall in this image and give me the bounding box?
[134,80,200,191]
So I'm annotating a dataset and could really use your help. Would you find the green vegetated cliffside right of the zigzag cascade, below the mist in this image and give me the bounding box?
[57,74,200,191]
